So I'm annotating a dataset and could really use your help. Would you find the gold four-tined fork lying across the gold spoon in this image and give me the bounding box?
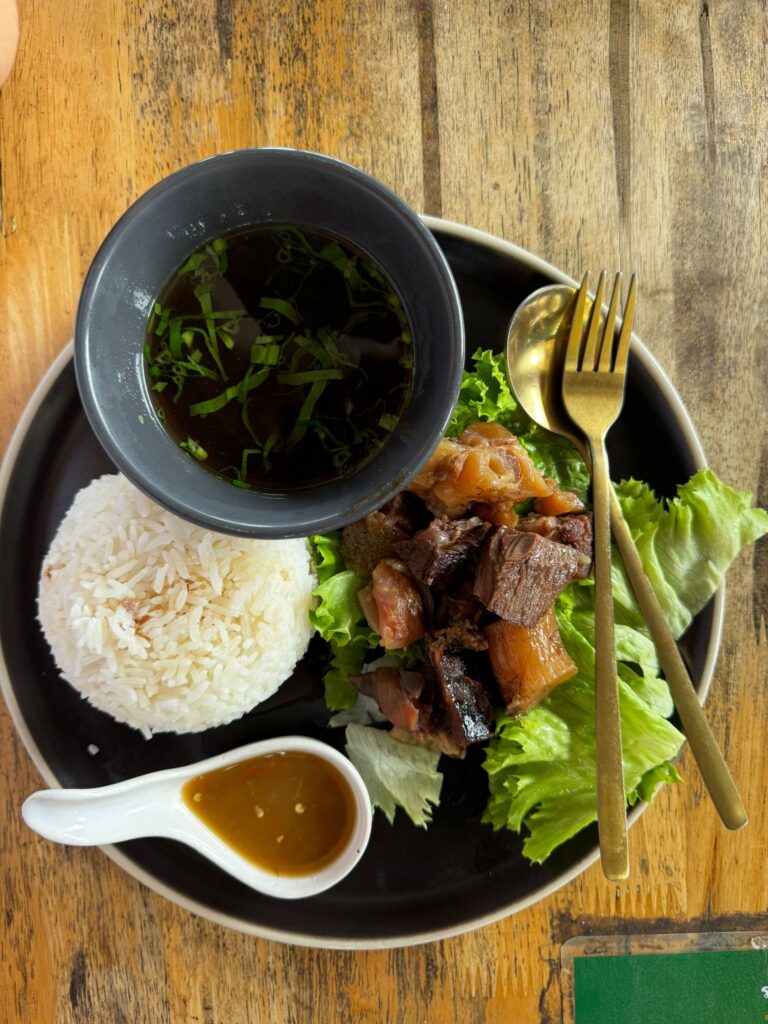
[562,270,637,881]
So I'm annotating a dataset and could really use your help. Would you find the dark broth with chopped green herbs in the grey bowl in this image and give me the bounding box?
[144,226,413,489]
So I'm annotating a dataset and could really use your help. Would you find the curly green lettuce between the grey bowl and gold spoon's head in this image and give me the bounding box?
[447,348,589,496]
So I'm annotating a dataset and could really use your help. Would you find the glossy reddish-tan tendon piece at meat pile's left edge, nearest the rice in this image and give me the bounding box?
[357,559,424,650]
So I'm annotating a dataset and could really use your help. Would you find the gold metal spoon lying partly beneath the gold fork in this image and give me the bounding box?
[507,285,746,829]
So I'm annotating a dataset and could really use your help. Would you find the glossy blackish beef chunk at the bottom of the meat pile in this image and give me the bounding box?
[427,631,494,748]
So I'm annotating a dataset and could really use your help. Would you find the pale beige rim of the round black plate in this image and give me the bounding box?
[0,215,725,950]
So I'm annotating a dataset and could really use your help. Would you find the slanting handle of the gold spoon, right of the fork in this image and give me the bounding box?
[610,487,746,829]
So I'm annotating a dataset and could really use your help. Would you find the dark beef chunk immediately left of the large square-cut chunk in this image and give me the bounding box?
[394,516,490,590]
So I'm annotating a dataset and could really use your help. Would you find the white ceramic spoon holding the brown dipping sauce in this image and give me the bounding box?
[22,736,372,899]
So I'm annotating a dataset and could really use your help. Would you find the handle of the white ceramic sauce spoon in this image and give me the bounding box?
[22,782,177,846]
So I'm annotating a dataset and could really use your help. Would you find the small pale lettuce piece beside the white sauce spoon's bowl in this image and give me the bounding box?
[346,724,442,828]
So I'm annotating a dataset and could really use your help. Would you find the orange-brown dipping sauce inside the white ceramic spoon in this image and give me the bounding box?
[181,751,355,876]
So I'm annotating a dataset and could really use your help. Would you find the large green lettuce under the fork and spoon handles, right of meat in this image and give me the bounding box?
[484,470,768,861]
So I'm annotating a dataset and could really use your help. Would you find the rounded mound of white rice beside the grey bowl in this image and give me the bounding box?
[38,475,316,736]
